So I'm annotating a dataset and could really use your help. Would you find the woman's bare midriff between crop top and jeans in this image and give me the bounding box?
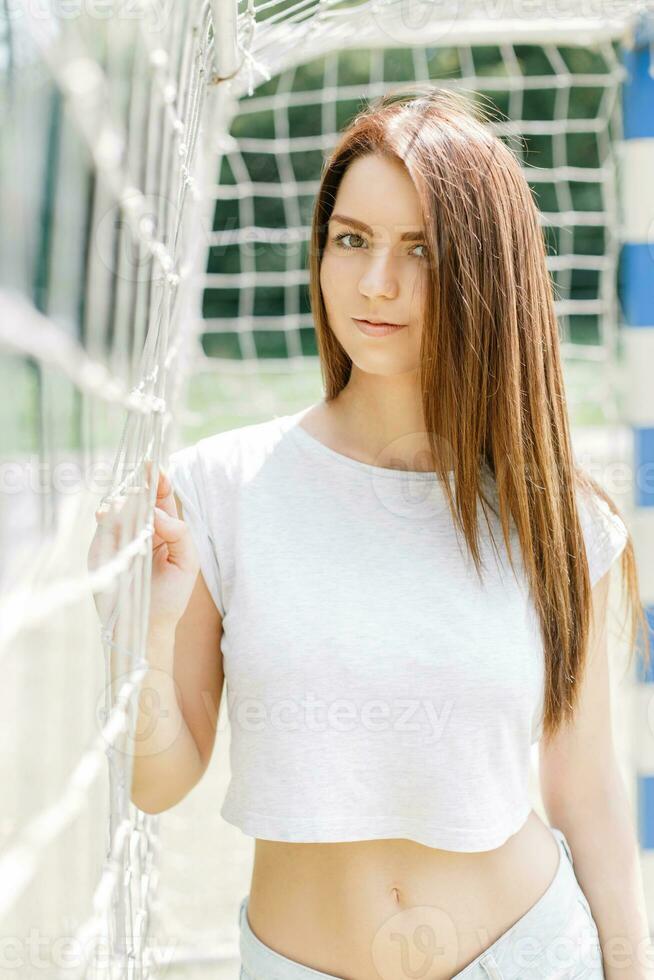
[248,810,560,980]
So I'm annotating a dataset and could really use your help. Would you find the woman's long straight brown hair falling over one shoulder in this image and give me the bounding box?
[309,83,650,738]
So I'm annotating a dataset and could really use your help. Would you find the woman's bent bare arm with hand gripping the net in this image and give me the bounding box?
[88,461,224,813]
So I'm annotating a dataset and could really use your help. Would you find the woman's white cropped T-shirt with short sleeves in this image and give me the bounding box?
[167,406,626,851]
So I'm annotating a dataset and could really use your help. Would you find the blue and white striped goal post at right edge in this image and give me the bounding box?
[620,14,654,932]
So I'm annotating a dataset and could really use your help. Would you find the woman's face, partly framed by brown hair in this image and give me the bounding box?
[320,155,428,375]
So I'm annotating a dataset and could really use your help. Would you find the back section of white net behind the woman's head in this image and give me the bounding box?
[183,3,654,436]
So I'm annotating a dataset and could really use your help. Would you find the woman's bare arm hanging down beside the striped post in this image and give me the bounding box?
[539,572,654,980]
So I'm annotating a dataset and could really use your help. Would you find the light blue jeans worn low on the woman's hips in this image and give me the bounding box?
[239,827,604,980]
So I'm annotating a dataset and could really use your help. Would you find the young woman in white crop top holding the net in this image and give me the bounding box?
[140,87,651,980]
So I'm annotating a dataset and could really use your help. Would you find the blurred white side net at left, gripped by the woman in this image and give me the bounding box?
[0,2,213,978]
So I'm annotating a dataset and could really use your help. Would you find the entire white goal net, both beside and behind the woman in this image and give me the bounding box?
[0,0,647,980]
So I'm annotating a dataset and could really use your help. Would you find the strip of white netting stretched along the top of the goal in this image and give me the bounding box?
[234,0,652,95]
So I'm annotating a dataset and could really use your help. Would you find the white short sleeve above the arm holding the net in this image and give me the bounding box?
[164,444,225,617]
